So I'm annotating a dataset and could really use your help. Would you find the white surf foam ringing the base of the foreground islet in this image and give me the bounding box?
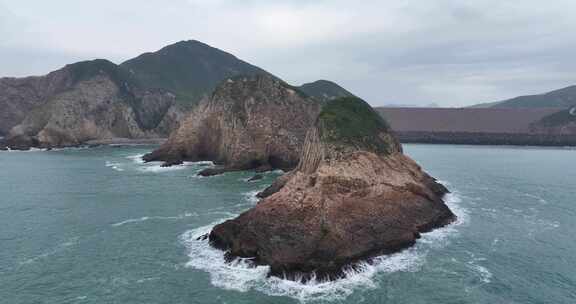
[180,191,468,302]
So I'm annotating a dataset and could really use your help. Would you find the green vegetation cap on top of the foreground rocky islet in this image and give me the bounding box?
[318,97,397,154]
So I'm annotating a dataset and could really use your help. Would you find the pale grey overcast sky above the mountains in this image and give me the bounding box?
[0,0,576,106]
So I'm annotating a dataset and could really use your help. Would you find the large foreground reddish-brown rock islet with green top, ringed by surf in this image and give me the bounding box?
[209,98,455,278]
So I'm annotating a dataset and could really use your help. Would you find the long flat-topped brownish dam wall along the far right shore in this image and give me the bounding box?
[378,107,576,146]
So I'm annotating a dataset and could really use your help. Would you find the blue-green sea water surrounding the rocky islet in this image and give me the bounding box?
[0,145,576,304]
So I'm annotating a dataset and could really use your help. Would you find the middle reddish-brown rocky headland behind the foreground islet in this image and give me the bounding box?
[144,75,320,175]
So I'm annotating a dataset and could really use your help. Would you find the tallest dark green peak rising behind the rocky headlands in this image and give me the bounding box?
[120,40,270,108]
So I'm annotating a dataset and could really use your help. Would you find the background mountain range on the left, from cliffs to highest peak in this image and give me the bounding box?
[0,40,352,149]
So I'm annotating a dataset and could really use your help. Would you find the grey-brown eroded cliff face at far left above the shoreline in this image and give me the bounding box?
[6,60,182,149]
